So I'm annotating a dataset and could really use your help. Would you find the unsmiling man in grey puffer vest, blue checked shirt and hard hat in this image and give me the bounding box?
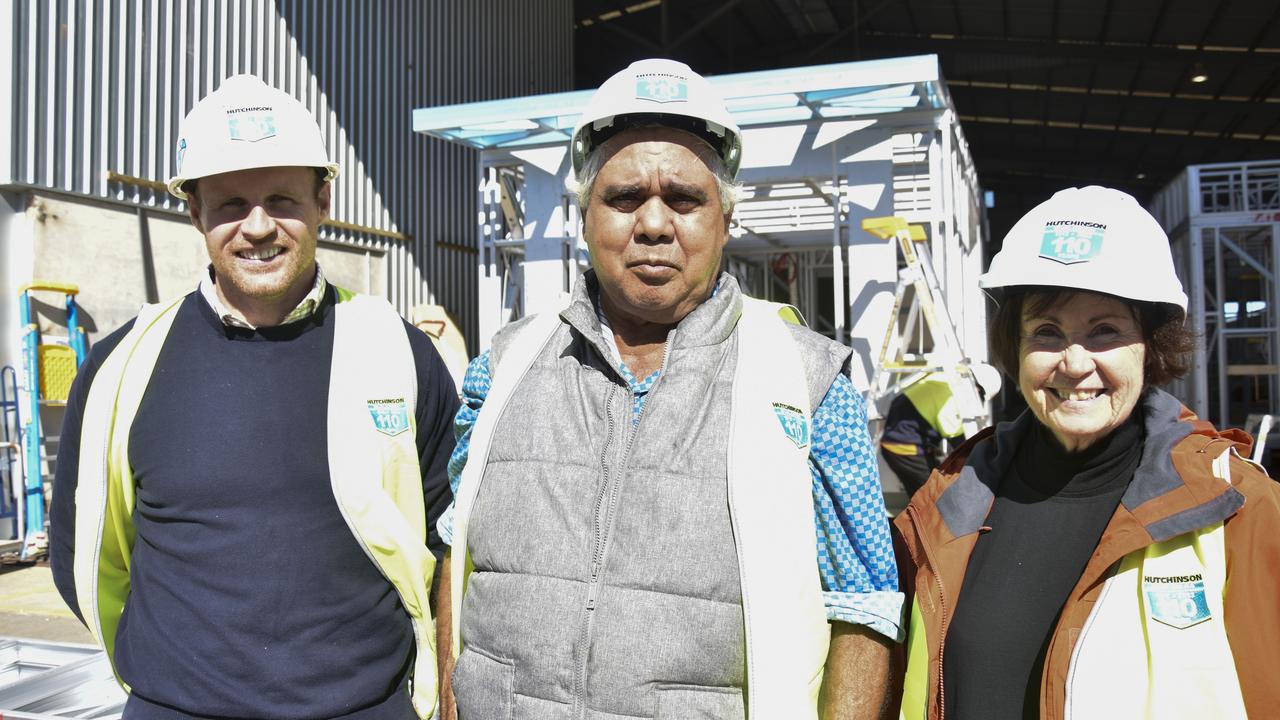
[436,60,902,720]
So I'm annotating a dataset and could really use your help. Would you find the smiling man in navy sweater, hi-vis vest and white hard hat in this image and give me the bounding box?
[51,76,458,719]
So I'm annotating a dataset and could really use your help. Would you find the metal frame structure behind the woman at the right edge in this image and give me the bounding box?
[1151,160,1280,428]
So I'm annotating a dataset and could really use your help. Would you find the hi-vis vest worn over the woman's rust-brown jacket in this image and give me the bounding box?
[901,450,1247,720]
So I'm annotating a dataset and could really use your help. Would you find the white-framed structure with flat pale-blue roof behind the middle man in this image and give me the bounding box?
[413,55,987,404]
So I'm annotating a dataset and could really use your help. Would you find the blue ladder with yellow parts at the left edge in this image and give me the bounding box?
[17,282,88,561]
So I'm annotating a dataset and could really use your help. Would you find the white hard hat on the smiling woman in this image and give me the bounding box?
[978,186,1187,316]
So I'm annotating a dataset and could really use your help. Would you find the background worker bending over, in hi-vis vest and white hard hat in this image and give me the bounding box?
[879,363,1001,497]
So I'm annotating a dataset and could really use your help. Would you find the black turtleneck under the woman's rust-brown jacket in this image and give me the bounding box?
[942,416,1143,720]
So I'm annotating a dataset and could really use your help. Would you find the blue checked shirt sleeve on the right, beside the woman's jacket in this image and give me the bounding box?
[809,374,904,642]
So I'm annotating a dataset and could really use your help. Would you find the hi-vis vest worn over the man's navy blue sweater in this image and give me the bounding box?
[74,290,436,717]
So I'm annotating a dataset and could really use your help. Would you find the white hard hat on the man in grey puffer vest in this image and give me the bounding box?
[572,58,742,178]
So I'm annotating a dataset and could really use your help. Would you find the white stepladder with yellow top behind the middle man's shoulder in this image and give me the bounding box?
[863,215,991,437]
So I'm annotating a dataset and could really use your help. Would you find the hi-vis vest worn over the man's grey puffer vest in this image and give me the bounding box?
[452,297,831,720]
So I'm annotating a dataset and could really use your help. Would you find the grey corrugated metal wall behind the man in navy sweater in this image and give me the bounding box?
[0,0,573,347]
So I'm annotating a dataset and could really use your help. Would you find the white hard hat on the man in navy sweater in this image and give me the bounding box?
[168,74,338,200]
